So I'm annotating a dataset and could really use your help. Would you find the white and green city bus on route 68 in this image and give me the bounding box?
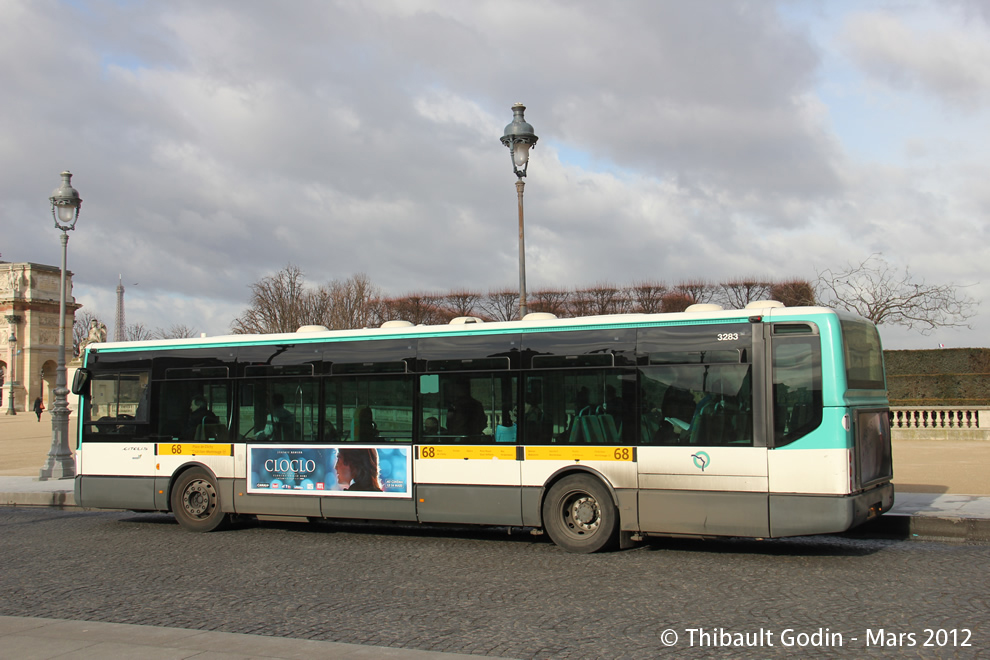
[72,301,894,553]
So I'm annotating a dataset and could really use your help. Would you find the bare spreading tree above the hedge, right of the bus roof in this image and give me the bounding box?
[817,253,977,335]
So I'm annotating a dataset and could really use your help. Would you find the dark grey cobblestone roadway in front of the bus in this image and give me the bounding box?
[0,507,990,658]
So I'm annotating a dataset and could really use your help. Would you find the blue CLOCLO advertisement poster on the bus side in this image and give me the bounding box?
[247,445,412,498]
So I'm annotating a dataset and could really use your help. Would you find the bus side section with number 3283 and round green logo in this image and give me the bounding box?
[638,323,769,536]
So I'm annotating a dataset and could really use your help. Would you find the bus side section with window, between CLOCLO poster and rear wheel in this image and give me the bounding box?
[413,372,522,525]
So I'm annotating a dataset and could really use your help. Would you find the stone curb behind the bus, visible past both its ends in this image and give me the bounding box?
[0,490,990,543]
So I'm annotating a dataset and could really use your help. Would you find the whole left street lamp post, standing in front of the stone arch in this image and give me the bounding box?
[39,172,82,481]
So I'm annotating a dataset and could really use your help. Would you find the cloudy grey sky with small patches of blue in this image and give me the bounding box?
[0,0,990,348]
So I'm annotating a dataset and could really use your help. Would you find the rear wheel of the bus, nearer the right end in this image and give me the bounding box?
[543,474,619,553]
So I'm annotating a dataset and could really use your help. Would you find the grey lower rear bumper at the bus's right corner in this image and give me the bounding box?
[770,483,894,538]
